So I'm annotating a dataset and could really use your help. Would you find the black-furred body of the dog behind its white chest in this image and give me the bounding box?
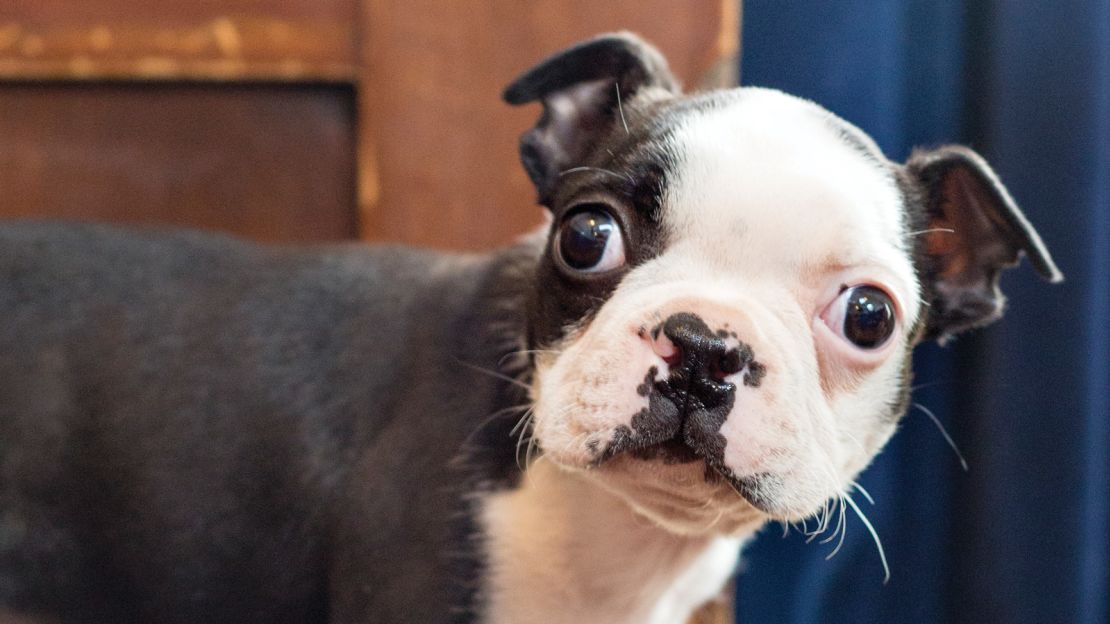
[0,223,526,622]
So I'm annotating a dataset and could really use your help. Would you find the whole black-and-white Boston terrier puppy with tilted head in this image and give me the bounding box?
[0,33,1061,624]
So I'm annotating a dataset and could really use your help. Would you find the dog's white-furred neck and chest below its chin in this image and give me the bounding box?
[481,460,740,624]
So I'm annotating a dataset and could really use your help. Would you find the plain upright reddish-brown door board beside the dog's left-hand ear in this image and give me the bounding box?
[360,0,739,249]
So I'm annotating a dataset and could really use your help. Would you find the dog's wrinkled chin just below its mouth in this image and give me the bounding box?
[585,446,768,535]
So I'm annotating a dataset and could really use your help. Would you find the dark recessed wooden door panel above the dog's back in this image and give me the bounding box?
[0,84,356,241]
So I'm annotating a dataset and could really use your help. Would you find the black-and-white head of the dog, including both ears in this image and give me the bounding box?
[505,34,1060,533]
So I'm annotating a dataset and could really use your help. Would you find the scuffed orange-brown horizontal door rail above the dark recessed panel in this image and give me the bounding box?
[0,0,359,82]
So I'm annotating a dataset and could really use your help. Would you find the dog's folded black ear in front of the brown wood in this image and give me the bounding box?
[503,32,679,205]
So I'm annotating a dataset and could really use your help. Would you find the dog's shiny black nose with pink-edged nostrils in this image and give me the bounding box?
[663,312,750,407]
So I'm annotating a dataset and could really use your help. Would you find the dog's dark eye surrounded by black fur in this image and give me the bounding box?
[555,205,625,273]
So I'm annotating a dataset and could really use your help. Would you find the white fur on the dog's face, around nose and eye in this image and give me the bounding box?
[533,89,921,524]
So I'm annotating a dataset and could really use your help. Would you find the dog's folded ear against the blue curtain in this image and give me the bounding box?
[906,145,1063,342]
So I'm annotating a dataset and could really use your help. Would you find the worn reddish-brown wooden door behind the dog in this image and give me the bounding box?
[0,0,739,249]
